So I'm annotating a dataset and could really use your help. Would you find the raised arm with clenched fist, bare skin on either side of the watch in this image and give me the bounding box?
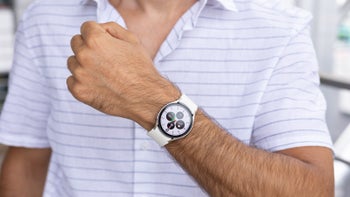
[67,22,334,197]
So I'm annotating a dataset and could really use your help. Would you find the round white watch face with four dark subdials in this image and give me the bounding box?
[158,103,193,138]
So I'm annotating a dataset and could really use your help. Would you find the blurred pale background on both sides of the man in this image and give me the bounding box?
[0,0,350,197]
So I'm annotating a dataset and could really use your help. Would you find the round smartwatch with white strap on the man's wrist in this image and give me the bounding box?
[147,94,198,146]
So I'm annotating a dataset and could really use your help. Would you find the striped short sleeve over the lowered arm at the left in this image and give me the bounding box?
[0,15,50,148]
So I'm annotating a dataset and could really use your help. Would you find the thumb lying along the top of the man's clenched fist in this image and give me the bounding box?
[101,22,139,44]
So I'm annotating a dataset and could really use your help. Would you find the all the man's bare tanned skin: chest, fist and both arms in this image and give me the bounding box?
[0,0,334,197]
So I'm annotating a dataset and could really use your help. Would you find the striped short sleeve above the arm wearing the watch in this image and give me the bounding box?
[251,19,332,151]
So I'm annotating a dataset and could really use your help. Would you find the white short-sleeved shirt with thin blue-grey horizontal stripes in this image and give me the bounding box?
[0,0,332,197]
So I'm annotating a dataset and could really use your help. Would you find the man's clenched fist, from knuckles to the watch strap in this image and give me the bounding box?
[67,22,180,129]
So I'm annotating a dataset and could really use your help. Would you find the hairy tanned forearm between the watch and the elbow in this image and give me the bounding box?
[166,112,332,197]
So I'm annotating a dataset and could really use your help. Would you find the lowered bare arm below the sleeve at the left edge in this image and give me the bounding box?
[0,147,51,197]
